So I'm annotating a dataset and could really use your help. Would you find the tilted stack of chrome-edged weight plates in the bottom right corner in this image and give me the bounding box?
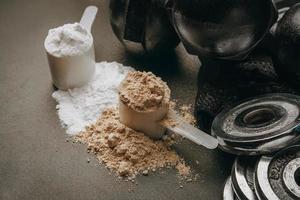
[223,145,300,200]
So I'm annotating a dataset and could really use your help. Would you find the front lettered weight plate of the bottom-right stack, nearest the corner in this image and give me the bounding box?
[255,145,300,200]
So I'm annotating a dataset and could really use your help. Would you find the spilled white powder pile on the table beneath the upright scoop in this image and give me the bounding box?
[52,62,133,135]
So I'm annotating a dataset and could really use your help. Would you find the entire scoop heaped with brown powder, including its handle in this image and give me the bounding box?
[119,71,218,149]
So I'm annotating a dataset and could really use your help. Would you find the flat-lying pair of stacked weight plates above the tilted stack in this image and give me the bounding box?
[212,93,300,155]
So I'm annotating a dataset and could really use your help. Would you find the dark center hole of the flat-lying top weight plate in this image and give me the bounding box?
[243,108,276,126]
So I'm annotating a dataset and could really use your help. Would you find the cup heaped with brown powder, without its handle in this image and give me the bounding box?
[119,71,171,139]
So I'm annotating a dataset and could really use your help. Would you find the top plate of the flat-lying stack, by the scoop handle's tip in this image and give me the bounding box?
[212,93,300,142]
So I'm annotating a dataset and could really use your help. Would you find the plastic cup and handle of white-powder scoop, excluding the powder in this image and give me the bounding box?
[45,6,98,90]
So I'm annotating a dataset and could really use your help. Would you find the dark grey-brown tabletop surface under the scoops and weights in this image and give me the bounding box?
[0,0,233,200]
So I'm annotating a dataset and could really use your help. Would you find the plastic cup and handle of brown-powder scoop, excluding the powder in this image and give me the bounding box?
[119,99,218,149]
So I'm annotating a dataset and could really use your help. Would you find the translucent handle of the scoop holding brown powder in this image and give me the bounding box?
[163,111,218,149]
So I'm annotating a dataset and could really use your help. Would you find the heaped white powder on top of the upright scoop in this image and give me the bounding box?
[44,23,93,57]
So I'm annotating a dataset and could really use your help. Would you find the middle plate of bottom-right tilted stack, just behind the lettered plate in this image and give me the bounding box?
[231,156,258,200]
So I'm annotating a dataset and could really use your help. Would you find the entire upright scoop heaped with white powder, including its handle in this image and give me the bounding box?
[44,6,97,90]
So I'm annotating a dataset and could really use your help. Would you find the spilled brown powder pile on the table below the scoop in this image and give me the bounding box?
[76,108,189,178]
